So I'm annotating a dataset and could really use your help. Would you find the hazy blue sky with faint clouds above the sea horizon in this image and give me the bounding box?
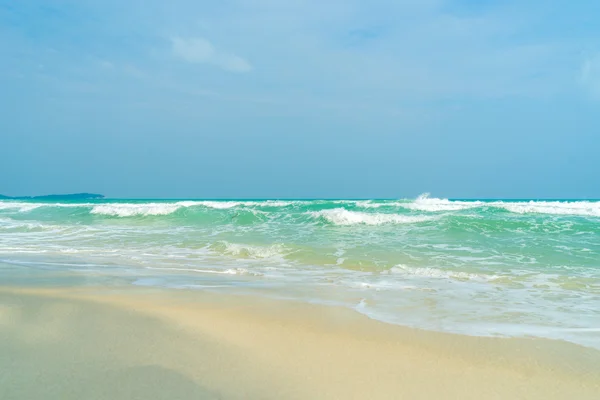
[0,0,600,198]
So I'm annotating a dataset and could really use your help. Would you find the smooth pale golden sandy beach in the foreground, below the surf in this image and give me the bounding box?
[0,287,600,400]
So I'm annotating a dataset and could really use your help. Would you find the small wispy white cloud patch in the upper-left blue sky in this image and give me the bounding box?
[171,37,252,72]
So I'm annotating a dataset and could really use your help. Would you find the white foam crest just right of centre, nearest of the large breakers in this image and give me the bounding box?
[310,208,433,225]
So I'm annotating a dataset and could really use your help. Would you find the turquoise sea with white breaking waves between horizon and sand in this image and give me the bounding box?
[0,196,600,348]
